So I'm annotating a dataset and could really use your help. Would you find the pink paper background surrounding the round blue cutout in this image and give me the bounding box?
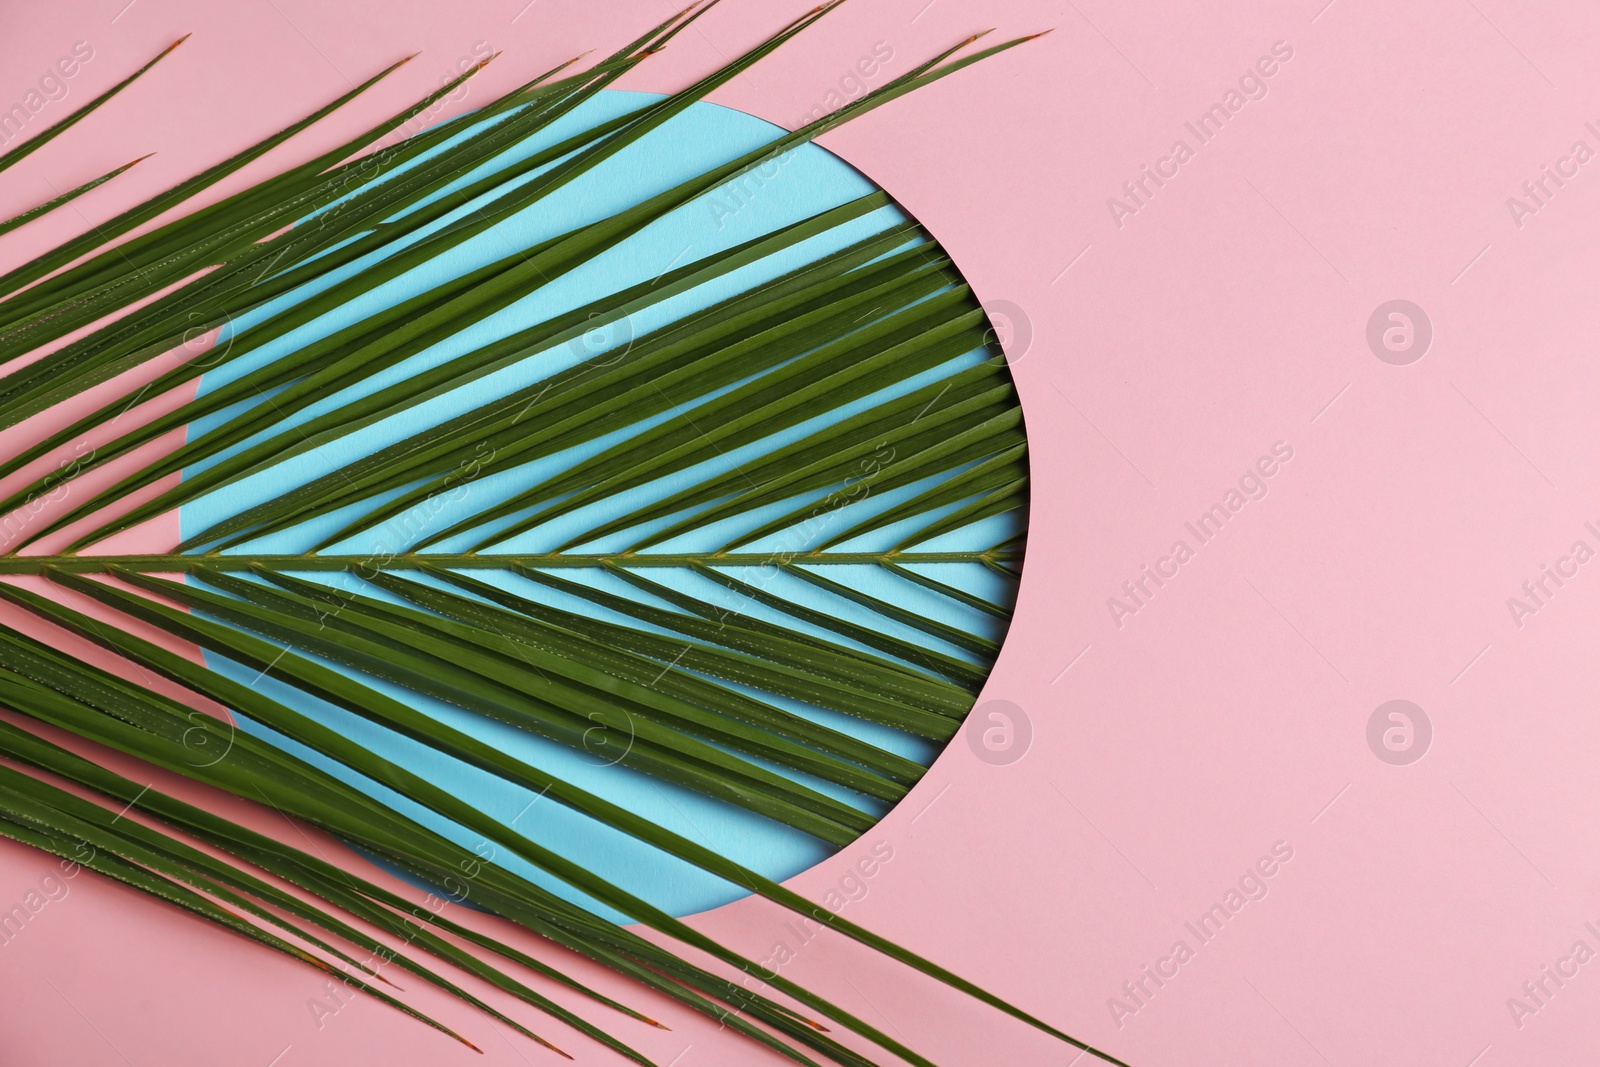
[0,0,1600,1067]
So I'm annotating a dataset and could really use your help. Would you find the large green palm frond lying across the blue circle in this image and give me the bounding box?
[0,10,1120,1067]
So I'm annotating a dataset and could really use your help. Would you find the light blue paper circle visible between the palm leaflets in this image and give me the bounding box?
[179,91,1019,918]
